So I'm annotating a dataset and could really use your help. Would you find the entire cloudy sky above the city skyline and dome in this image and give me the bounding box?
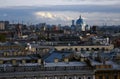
[0,0,120,25]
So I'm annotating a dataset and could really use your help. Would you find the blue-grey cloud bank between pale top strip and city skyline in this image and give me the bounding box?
[0,5,120,25]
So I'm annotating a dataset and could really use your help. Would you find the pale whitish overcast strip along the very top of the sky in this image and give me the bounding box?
[0,0,120,7]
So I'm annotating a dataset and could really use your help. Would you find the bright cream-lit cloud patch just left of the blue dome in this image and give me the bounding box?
[33,11,74,25]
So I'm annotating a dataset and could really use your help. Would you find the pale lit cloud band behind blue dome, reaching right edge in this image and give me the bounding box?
[35,11,120,25]
